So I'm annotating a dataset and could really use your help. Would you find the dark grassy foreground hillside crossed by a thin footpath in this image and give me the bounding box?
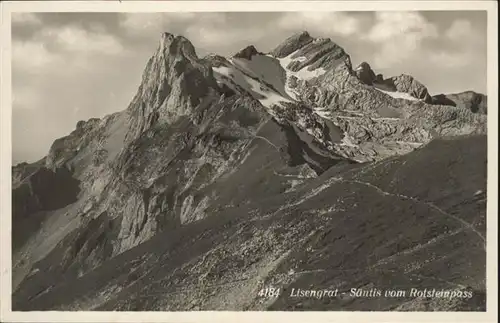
[14,136,486,310]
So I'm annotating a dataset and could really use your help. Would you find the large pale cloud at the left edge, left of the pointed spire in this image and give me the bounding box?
[12,18,130,119]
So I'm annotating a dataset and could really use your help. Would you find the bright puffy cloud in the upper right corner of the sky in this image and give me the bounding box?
[365,12,485,71]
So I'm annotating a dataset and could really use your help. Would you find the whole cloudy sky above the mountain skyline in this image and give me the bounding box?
[12,11,487,164]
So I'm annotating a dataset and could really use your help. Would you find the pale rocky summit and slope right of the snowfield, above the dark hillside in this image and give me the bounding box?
[274,36,486,161]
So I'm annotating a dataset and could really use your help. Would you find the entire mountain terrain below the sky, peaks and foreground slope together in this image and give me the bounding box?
[13,32,486,310]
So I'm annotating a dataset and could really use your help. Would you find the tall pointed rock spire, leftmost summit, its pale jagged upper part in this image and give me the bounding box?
[127,32,216,139]
